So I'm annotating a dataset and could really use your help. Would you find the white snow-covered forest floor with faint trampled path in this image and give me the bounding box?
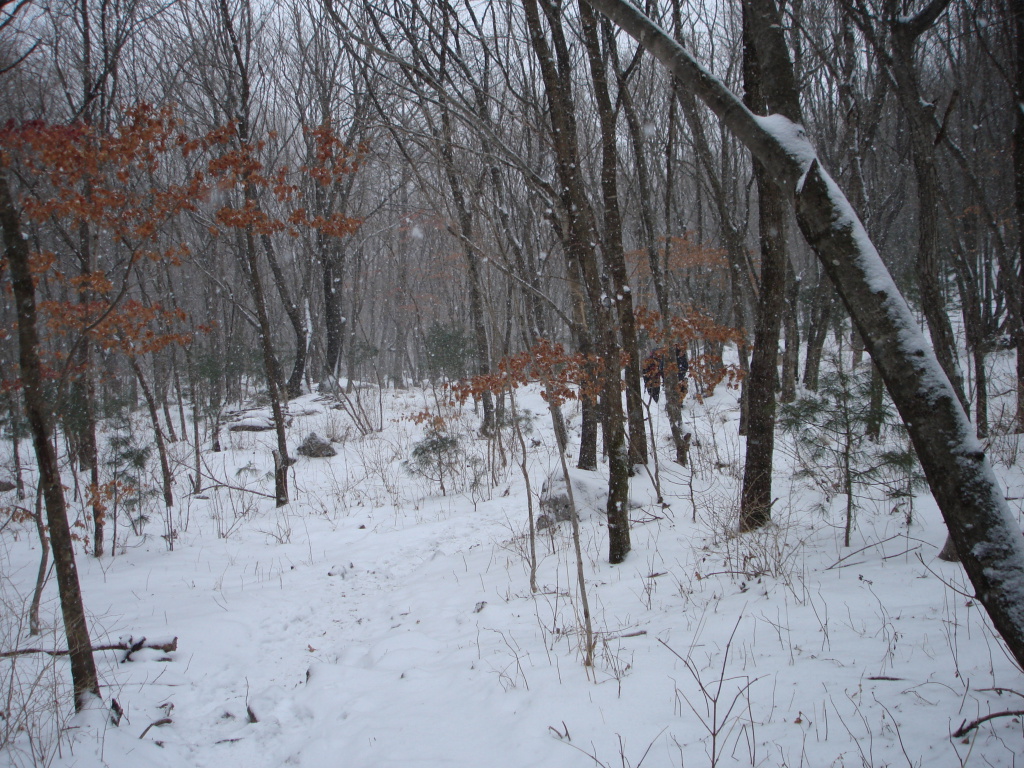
[0,368,1024,768]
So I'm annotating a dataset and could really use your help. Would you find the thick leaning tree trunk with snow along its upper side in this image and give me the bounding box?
[587,0,1024,667]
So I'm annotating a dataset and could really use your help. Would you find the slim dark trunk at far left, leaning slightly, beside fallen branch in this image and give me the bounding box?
[0,174,99,711]
